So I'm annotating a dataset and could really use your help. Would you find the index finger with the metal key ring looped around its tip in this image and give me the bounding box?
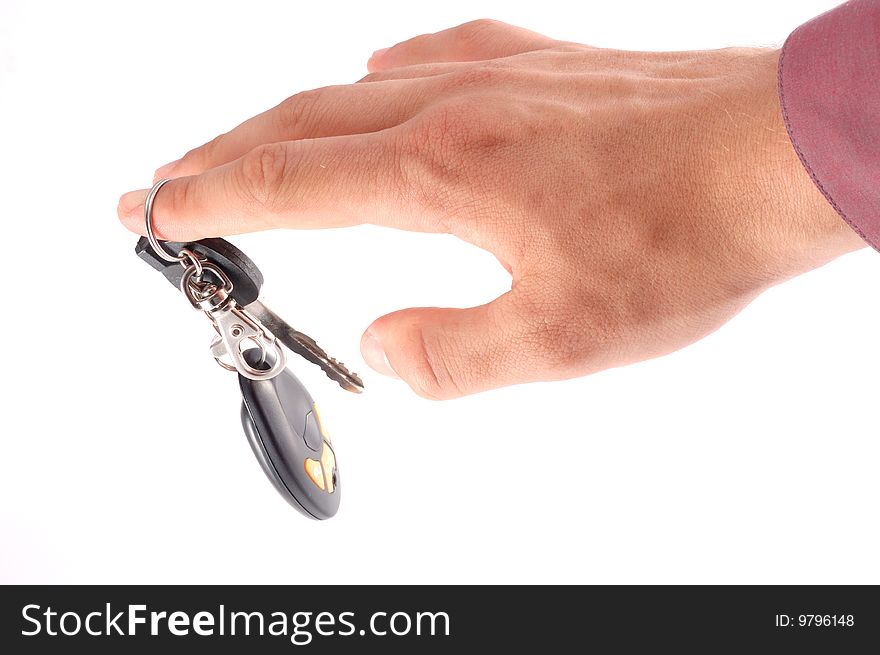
[117,129,447,241]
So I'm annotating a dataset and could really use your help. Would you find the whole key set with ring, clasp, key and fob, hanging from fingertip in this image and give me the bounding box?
[135,180,364,519]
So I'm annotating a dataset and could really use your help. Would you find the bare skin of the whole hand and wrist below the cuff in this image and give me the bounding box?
[118,20,864,399]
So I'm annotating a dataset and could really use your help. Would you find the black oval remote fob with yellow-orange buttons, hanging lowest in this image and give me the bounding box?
[238,348,340,519]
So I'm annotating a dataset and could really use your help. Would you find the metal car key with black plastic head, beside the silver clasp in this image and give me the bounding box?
[135,237,364,393]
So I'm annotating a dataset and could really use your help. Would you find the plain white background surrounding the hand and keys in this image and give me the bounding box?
[0,0,880,583]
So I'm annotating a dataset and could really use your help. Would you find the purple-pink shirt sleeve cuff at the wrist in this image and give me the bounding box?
[779,0,880,250]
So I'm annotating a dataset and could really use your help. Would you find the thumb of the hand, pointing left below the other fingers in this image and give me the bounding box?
[361,292,535,400]
